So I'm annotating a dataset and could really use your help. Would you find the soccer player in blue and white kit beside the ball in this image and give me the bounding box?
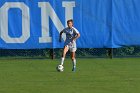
[59,19,80,72]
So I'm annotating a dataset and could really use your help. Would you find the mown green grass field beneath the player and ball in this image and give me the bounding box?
[0,58,140,93]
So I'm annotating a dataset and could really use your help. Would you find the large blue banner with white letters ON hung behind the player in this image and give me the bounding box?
[0,0,140,49]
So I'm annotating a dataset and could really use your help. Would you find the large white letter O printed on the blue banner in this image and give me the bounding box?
[0,2,30,43]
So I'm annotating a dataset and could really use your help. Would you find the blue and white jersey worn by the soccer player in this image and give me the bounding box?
[62,27,79,46]
